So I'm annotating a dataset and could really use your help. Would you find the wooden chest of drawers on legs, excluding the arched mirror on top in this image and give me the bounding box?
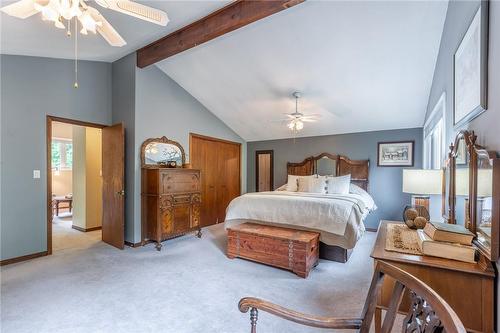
[142,168,201,251]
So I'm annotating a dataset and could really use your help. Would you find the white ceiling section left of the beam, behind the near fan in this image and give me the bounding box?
[0,0,228,62]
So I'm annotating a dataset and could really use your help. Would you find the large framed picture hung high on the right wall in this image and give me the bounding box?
[453,0,488,128]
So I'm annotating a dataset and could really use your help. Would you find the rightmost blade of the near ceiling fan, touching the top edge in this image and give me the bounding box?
[96,0,169,26]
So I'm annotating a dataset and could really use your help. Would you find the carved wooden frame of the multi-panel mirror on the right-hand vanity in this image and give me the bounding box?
[443,130,500,262]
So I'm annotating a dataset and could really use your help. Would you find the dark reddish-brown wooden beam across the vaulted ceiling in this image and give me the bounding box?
[137,0,304,68]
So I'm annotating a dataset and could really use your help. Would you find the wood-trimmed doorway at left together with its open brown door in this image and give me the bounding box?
[47,116,125,254]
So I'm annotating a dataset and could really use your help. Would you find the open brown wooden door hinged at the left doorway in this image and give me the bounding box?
[102,124,125,249]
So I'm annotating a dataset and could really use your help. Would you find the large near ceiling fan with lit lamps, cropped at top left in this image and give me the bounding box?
[0,0,168,47]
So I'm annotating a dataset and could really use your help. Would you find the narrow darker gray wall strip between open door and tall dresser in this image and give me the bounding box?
[112,53,140,242]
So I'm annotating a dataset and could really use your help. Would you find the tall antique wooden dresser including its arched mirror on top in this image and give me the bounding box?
[141,136,202,251]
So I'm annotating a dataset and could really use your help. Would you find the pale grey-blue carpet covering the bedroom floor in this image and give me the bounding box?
[1,225,375,333]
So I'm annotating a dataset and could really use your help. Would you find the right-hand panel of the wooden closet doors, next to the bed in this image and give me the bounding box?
[217,142,241,223]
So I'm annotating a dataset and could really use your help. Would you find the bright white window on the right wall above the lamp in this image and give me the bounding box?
[424,93,446,169]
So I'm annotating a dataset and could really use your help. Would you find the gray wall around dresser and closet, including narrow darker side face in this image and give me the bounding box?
[113,54,246,243]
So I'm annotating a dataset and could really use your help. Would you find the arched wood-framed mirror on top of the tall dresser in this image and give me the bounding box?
[141,137,186,168]
